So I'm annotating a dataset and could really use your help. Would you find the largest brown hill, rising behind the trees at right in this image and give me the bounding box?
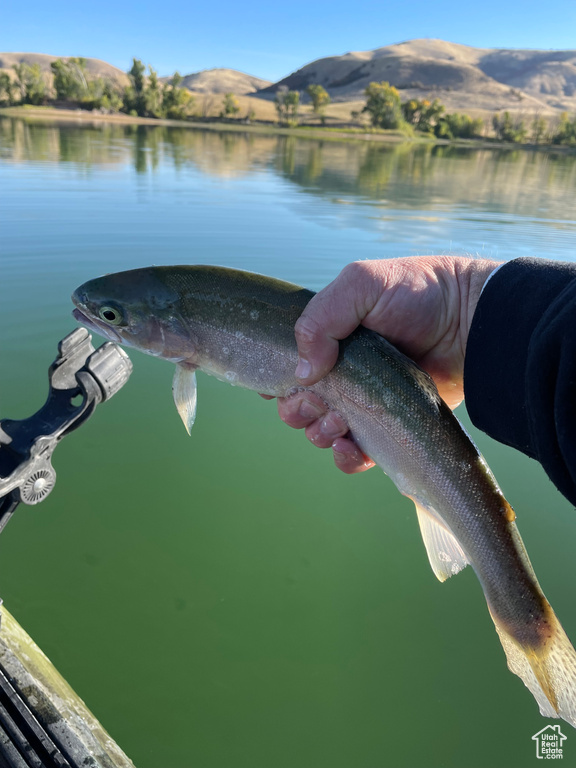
[258,39,576,112]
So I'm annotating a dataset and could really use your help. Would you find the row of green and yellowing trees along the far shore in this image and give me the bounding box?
[0,57,576,146]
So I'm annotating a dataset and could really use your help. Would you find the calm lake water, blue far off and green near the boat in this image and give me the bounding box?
[0,119,576,768]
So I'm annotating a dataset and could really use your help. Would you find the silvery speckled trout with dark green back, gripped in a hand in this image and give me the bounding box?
[72,265,576,727]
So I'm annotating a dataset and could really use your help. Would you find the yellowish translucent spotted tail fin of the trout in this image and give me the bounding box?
[490,602,576,728]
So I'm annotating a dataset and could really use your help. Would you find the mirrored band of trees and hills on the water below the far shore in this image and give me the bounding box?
[0,118,576,221]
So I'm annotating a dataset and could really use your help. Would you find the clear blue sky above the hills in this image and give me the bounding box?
[0,0,576,81]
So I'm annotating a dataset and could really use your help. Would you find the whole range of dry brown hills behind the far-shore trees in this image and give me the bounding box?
[0,39,576,117]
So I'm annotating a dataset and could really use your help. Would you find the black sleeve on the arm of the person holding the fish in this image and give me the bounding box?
[464,259,576,505]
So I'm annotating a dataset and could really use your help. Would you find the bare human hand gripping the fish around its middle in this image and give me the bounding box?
[270,256,498,474]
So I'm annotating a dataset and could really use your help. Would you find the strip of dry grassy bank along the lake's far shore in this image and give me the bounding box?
[0,106,576,154]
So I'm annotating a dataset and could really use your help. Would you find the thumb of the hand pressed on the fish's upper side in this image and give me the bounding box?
[294,262,377,386]
